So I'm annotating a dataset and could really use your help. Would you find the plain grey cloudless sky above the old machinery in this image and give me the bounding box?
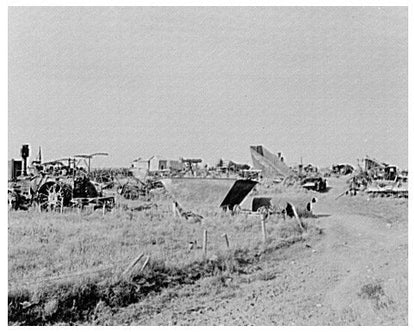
[8,7,408,168]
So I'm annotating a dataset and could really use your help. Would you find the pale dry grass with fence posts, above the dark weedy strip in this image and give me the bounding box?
[9,204,316,288]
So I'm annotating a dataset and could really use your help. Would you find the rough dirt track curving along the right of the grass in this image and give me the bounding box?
[95,180,408,325]
